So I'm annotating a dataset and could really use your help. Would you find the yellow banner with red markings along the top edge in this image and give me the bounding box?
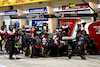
[0,0,49,6]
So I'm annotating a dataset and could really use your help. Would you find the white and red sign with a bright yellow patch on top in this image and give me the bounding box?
[54,3,90,12]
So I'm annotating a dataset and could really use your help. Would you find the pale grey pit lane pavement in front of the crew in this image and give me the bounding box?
[0,54,100,67]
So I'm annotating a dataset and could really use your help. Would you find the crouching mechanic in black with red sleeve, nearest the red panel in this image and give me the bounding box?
[68,37,86,60]
